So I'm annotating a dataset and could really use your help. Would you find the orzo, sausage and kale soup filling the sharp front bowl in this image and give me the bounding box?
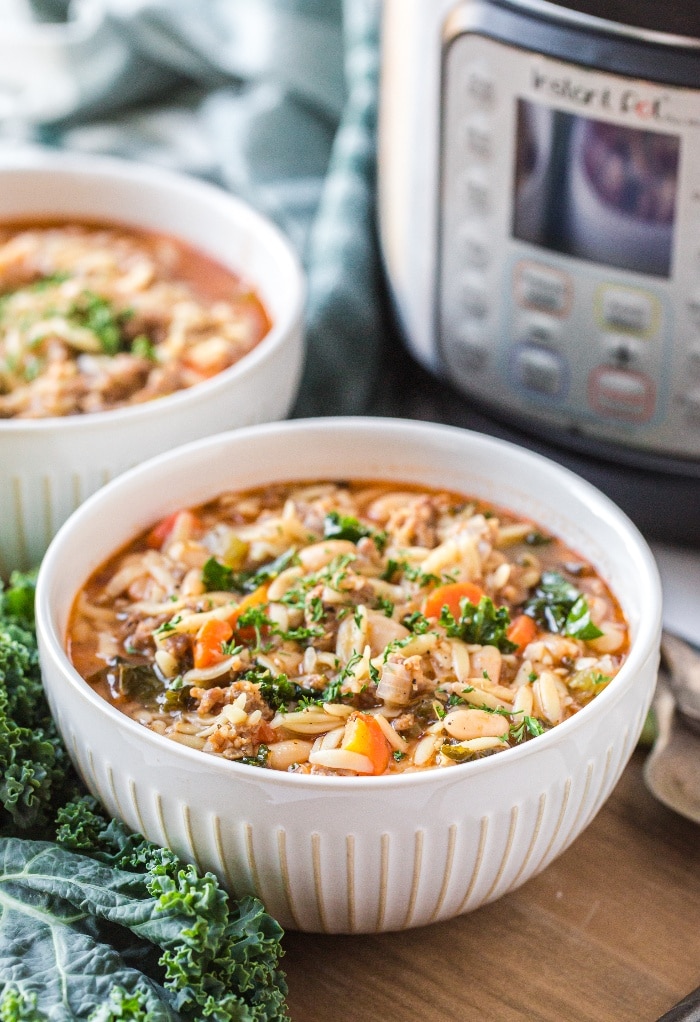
[67,481,628,776]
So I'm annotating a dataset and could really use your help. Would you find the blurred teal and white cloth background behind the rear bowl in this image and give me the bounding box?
[0,0,383,415]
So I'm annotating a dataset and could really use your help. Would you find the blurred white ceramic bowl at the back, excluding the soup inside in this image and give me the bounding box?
[0,150,305,576]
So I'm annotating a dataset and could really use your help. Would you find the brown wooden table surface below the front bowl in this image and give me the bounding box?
[283,751,700,1022]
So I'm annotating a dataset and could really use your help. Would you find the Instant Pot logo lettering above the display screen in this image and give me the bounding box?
[530,67,700,127]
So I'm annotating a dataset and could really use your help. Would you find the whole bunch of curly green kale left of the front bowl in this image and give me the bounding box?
[0,574,288,1022]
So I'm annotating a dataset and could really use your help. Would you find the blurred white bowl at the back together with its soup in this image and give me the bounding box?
[0,149,305,576]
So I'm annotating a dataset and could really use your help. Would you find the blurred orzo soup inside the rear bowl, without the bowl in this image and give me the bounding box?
[0,223,270,419]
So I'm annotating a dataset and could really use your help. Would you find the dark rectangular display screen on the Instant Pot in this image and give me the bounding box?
[512,99,681,277]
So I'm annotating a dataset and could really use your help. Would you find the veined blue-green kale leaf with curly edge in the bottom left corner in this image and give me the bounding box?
[0,797,287,1022]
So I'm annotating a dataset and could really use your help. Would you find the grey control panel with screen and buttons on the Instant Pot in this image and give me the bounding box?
[437,32,700,457]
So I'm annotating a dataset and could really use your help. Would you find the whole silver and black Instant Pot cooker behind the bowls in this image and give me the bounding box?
[379,0,700,543]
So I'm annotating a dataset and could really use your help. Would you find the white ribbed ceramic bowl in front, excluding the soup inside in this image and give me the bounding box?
[37,418,661,932]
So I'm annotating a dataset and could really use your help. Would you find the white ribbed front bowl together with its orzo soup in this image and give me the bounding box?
[37,418,661,932]
